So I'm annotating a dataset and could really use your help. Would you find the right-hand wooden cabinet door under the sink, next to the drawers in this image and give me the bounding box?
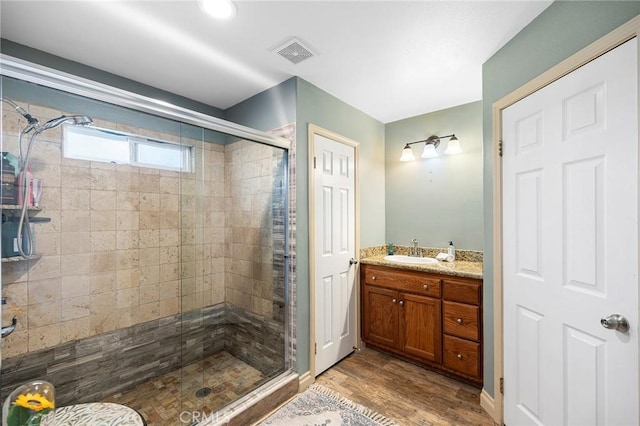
[400,293,442,363]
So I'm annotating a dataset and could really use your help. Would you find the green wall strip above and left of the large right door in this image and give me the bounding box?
[482,1,640,395]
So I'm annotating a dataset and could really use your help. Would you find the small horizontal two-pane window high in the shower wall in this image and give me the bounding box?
[63,126,194,173]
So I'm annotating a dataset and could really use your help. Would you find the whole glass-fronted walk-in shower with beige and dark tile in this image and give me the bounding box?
[1,62,295,425]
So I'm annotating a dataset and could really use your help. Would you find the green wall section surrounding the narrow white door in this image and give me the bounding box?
[296,78,385,374]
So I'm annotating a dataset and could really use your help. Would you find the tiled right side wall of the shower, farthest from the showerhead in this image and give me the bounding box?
[225,125,288,370]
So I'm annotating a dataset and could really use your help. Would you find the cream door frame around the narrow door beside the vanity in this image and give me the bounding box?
[308,123,362,380]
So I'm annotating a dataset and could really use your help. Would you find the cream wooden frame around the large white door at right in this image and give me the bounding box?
[490,15,640,425]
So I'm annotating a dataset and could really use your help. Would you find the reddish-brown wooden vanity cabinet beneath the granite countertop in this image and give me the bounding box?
[361,265,482,385]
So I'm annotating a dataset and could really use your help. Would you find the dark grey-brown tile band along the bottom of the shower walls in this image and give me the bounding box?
[0,303,287,405]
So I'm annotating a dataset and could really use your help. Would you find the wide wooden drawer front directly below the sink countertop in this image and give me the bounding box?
[362,265,441,297]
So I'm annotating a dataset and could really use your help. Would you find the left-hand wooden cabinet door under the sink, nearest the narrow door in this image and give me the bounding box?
[362,285,400,349]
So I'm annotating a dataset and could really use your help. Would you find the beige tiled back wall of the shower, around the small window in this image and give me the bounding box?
[2,101,222,359]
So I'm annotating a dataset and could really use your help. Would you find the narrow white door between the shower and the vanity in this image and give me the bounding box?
[312,134,357,375]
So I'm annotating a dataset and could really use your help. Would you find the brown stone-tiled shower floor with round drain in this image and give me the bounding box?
[103,352,266,426]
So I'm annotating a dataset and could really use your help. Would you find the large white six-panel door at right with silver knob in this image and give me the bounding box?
[502,39,640,426]
